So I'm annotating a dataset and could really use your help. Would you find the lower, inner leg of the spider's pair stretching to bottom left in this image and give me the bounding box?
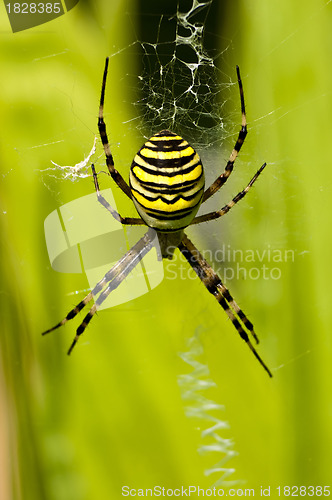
[67,230,155,355]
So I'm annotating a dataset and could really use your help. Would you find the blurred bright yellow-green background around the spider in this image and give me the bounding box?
[0,0,332,500]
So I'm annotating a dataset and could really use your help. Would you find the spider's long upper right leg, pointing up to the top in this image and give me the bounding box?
[202,66,248,203]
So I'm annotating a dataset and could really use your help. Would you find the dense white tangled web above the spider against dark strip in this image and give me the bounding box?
[134,0,233,150]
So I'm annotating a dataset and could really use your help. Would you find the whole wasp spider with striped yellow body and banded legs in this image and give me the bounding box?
[43,58,272,377]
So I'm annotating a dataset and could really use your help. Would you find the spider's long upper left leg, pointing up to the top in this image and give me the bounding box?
[98,57,131,199]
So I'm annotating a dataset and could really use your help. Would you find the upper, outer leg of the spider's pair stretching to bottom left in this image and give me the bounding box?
[42,230,154,346]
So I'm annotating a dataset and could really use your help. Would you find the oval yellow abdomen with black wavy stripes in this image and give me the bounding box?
[129,130,204,232]
